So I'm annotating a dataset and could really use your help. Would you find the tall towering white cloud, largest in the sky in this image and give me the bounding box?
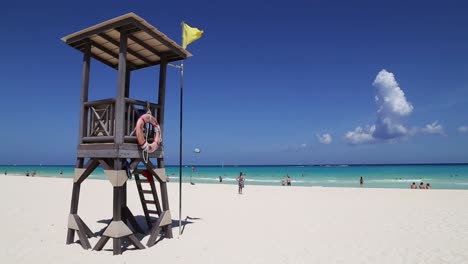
[345,69,414,144]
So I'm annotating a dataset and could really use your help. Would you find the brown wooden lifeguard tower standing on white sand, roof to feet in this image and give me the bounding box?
[62,13,191,254]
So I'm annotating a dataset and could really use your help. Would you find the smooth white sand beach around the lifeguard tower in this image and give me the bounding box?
[0,176,468,264]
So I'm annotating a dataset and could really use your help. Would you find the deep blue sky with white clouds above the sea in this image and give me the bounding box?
[0,0,468,164]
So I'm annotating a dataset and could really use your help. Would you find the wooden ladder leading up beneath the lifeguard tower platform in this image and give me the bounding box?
[133,170,162,229]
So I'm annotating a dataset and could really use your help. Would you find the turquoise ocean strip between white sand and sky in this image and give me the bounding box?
[0,164,468,189]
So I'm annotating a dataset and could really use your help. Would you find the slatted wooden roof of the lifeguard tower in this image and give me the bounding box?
[62,13,192,70]
